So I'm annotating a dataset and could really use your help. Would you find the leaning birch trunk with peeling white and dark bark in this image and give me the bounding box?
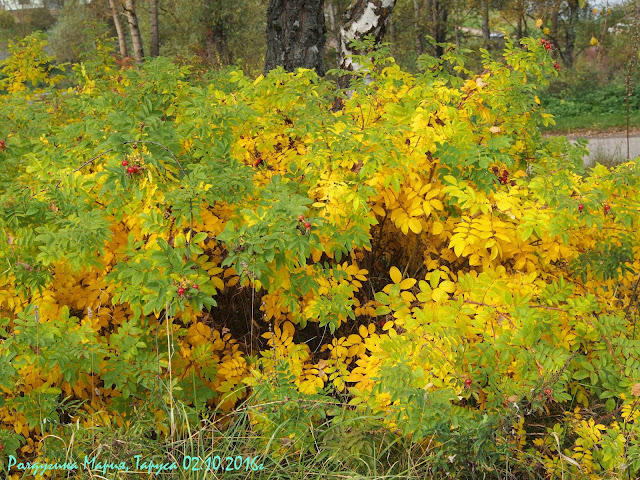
[340,0,396,70]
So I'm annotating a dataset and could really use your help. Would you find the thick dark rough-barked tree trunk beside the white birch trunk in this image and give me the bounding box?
[264,0,326,75]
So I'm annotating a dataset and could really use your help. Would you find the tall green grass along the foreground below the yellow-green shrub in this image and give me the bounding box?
[21,404,444,480]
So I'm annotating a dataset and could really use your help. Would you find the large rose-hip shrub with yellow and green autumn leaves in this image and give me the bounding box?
[0,32,640,478]
